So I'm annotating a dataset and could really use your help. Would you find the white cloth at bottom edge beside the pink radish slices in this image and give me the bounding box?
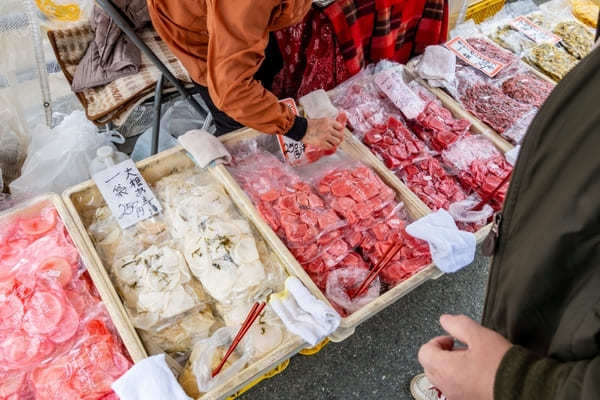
[111,354,192,400]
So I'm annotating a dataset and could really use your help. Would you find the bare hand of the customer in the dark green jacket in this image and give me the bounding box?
[419,315,512,400]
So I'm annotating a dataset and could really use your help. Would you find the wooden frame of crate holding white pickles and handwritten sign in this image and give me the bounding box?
[63,147,306,400]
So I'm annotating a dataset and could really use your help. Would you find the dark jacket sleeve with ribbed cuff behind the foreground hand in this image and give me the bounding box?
[494,346,600,400]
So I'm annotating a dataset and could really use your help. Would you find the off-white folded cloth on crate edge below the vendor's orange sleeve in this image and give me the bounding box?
[177,129,231,168]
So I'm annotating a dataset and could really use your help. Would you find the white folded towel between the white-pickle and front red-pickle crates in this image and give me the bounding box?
[270,277,342,346]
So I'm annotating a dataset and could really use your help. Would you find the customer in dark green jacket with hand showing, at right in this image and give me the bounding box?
[419,36,600,400]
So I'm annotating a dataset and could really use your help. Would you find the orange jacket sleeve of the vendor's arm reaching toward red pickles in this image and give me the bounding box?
[207,0,306,135]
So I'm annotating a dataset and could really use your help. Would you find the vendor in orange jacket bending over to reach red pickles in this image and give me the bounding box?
[148,0,344,150]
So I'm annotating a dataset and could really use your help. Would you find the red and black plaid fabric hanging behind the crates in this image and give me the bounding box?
[325,0,448,75]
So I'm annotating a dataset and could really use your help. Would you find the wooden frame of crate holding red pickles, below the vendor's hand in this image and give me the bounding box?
[211,129,442,342]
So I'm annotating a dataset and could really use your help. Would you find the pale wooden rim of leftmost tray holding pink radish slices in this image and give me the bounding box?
[0,194,147,362]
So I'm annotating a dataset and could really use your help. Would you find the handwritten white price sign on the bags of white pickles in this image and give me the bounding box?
[92,160,162,229]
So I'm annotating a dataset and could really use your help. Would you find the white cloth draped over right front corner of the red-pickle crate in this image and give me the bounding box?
[406,210,477,273]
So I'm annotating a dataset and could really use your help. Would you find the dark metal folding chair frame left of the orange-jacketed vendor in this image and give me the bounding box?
[95,0,212,155]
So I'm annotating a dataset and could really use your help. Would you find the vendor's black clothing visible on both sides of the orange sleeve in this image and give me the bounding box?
[198,33,283,136]
